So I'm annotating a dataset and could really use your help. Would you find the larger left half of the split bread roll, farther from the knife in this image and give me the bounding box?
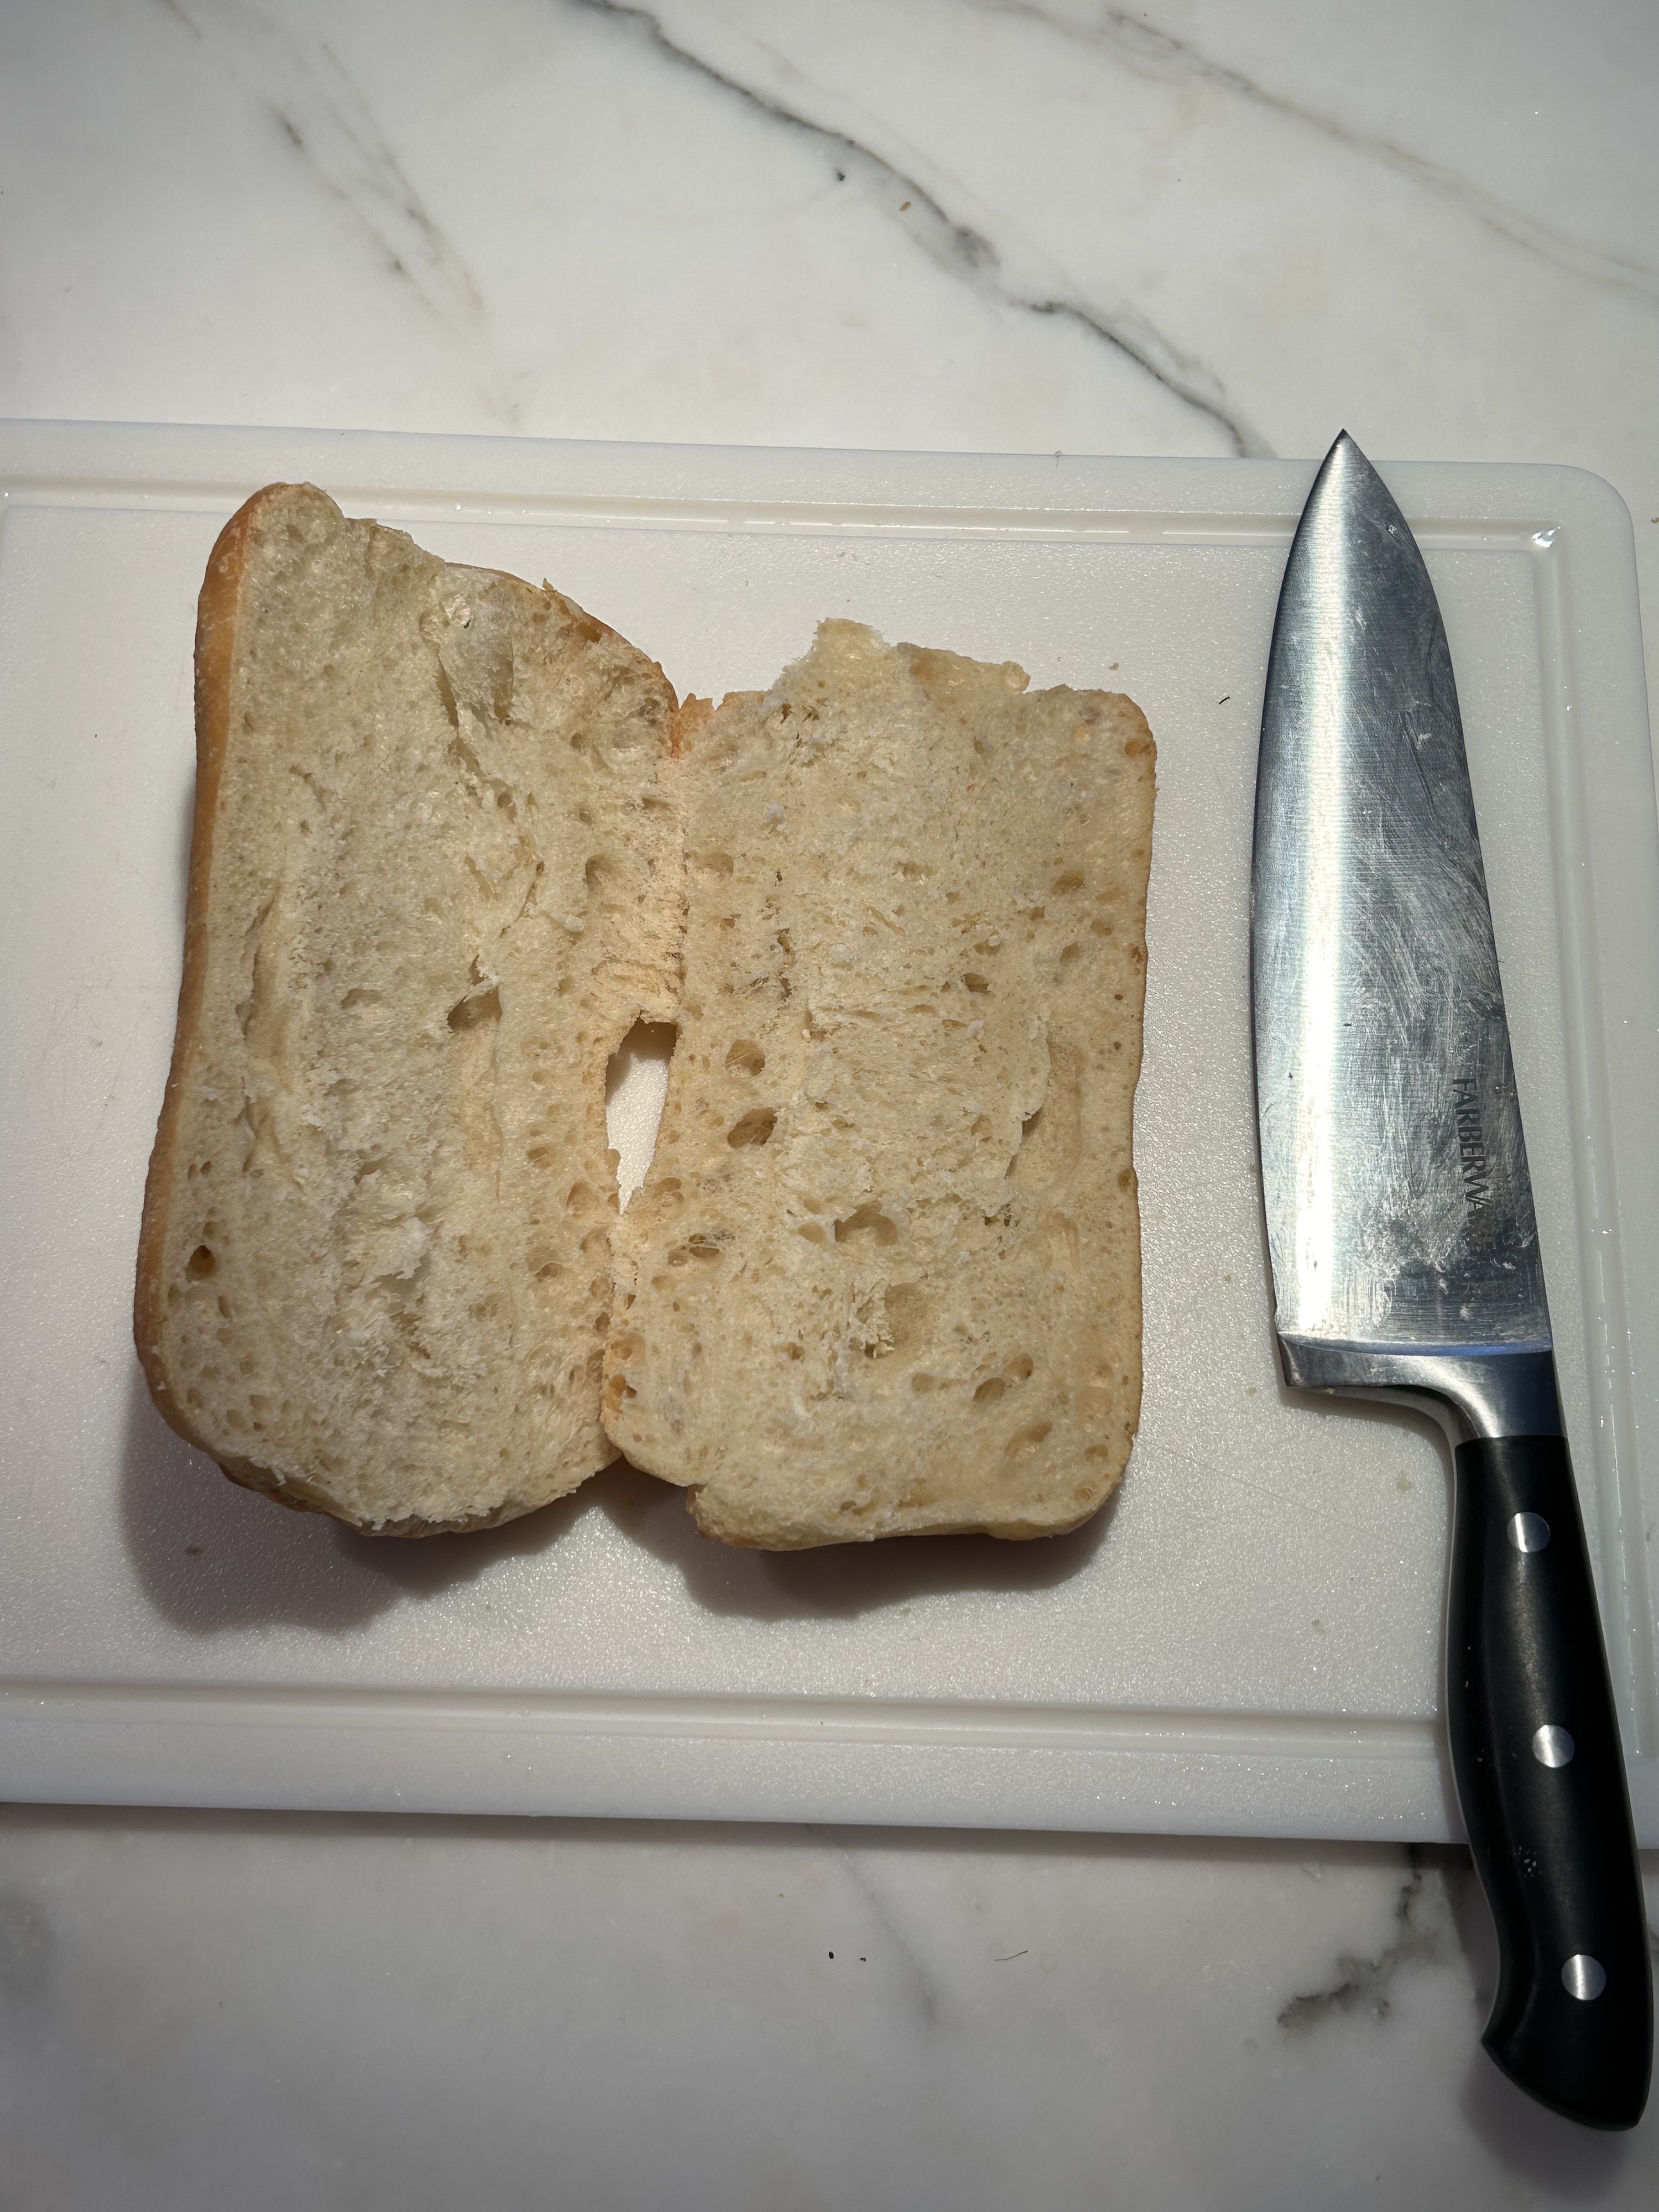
[135,484,681,1535]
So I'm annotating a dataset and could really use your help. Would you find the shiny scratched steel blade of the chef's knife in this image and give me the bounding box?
[1252,434,1551,1387]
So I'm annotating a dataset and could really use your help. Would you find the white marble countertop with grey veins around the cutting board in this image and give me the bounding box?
[0,0,1659,2212]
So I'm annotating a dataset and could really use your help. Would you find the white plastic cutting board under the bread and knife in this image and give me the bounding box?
[0,425,1659,1843]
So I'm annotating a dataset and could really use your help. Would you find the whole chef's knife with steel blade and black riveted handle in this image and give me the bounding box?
[1252,434,1652,2128]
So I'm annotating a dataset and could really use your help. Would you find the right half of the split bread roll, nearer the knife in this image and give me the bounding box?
[606,622,1155,1548]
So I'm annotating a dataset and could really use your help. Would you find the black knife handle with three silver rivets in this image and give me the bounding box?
[1447,1436,1652,2128]
